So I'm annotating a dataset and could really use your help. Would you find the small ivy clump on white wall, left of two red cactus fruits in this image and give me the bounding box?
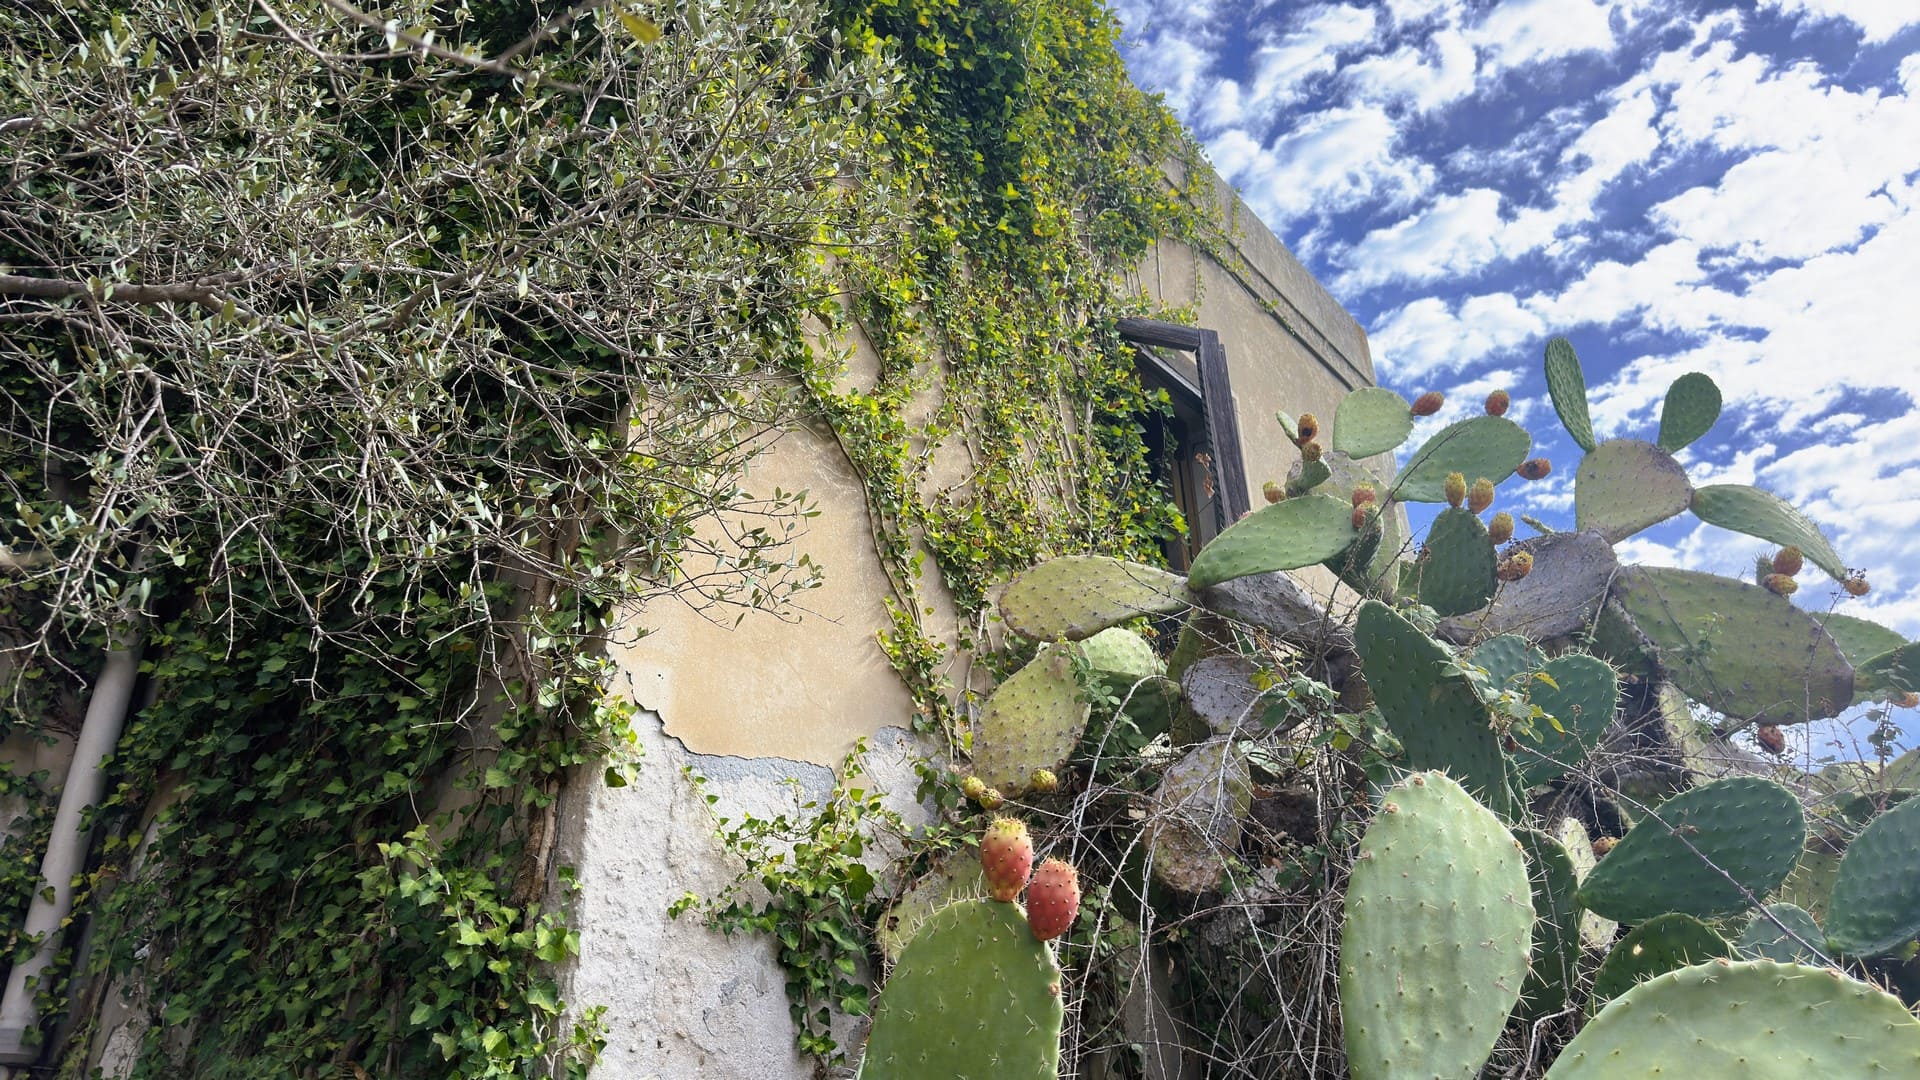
[670,746,902,1065]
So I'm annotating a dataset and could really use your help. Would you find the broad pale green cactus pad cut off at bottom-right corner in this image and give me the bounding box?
[1548,961,1920,1080]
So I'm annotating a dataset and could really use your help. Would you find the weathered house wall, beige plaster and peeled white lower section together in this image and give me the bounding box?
[557,171,1373,1080]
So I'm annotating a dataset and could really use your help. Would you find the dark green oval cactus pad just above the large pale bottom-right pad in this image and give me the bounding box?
[1580,776,1807,922]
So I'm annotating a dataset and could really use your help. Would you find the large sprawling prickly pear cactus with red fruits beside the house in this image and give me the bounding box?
[868,338,1920,1080]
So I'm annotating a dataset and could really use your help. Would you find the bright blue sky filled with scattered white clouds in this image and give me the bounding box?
[1116,0,1920,753]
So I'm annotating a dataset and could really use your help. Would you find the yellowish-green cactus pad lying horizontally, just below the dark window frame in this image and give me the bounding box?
[1000,555,1187,642]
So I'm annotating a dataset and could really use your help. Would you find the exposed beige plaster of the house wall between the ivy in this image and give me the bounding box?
[614,171,1373,765]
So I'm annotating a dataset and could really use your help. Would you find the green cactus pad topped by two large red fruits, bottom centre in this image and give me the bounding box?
[860,899,1066,1080]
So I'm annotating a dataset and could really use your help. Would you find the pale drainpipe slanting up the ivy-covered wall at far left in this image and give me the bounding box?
[0,630,144,1076]
